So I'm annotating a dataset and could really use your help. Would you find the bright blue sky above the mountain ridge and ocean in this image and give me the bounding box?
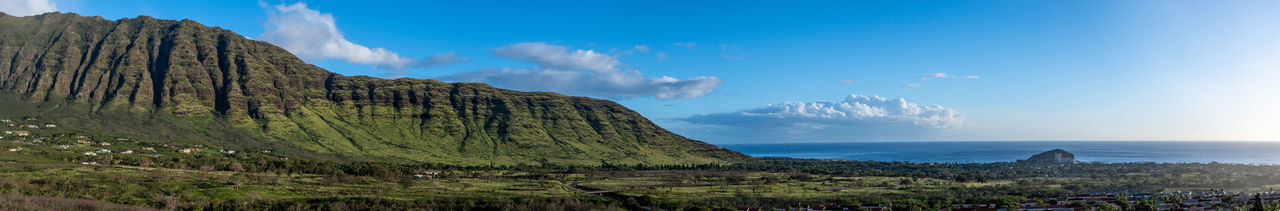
[0,0,1280,143]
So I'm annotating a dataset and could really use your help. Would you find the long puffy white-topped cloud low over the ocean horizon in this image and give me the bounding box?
[677,95,965,141]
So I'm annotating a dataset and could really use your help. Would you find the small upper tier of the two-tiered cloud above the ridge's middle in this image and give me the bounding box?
[493,42,622,72]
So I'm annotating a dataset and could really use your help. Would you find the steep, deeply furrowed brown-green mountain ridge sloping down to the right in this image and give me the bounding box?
[0,13,746,165]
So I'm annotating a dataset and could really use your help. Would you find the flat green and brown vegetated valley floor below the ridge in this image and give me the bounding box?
[0,127,1280,210]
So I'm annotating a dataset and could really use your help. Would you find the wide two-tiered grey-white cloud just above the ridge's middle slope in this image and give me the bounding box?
[436,42,722,98]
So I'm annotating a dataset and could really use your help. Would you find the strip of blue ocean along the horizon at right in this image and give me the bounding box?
[721,141,1280,165]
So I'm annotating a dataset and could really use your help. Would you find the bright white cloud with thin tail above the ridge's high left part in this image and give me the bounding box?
[257,3,468,69]
